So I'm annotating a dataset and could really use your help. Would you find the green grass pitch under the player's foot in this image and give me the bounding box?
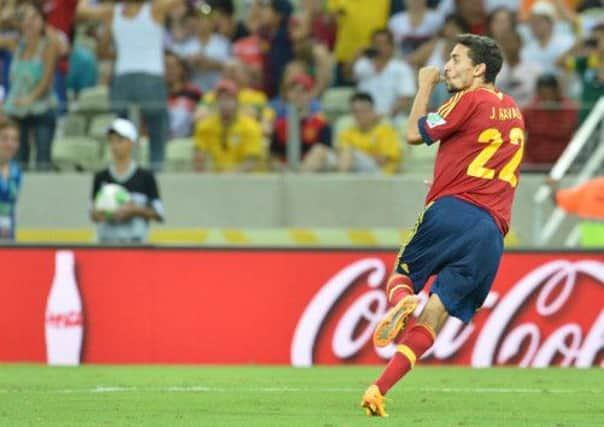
[0,365,604,427]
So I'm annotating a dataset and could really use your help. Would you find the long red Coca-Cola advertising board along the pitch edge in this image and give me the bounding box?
[0,248,604,367]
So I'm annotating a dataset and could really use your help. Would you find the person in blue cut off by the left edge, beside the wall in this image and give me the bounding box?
[0,117,21,241]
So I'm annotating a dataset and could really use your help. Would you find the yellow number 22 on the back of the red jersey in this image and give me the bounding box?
[468,128,524,187]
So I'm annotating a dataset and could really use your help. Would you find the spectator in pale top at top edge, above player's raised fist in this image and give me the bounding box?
[388,0,443,55]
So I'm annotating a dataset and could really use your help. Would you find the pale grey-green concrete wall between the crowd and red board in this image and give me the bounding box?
[17,173,572,244]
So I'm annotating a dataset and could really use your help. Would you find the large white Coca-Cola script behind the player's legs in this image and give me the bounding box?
[291,258,604,367]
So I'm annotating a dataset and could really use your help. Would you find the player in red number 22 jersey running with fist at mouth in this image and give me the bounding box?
[361,34,524,416]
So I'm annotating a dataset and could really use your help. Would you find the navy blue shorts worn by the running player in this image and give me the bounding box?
[395,197,503,323]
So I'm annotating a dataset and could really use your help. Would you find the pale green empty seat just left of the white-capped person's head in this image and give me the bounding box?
[52,136,101,172]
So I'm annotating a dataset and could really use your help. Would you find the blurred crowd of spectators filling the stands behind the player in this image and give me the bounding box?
[0,0,604,174]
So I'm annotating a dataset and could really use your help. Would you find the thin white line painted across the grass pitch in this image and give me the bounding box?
[0,386,602,394]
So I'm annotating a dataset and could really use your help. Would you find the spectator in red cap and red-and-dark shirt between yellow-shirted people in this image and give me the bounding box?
[270,74,331,172]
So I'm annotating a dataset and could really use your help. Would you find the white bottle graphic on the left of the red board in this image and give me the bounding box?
[46,251,84,365]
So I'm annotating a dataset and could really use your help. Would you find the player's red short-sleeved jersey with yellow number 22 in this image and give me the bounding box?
[419,88,525,235]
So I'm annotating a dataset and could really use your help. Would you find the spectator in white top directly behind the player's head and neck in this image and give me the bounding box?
[497,31,541,108]
